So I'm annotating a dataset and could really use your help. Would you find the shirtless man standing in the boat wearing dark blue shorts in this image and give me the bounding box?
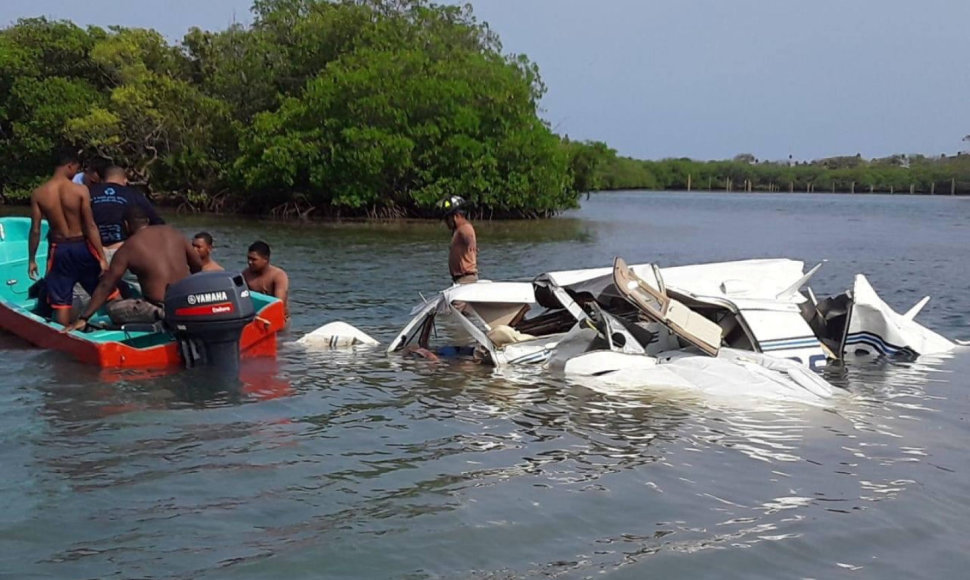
[27,153,108,326]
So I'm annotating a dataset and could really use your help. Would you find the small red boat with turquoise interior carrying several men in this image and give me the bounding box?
[0,217,286,368]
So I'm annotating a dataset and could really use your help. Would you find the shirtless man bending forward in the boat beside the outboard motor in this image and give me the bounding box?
[64,204,202,332]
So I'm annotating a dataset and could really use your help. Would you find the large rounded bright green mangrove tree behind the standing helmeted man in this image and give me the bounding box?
[235,1,576,215]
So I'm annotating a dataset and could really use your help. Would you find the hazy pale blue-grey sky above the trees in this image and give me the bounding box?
[0,0,970,160]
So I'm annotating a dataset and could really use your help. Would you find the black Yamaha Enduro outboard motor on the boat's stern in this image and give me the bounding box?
[165,272,256,378]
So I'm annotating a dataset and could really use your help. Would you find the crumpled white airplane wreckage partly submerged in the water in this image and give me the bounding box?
[298,258,956,401]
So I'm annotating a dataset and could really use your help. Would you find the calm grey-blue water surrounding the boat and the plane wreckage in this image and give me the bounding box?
[0,193,970,579]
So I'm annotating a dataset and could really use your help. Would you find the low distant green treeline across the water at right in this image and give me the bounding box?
[592,150,970,195]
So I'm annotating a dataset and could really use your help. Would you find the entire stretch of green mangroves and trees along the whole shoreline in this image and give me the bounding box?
[0,0,970,219]
